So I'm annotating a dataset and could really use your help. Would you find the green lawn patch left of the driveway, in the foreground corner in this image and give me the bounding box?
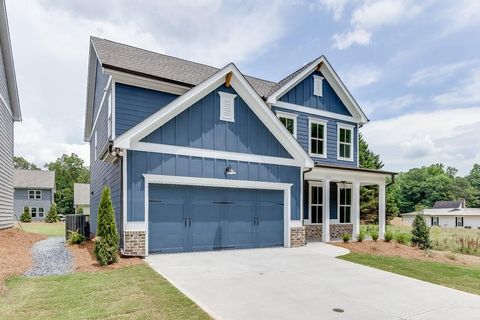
[0,265,210,320]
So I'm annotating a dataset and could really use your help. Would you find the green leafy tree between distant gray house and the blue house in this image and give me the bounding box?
[45,153,90,214]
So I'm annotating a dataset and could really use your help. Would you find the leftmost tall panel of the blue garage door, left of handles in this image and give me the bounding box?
[148,201,185,252]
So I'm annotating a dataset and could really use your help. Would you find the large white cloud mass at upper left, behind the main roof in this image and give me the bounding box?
[7,0,287,164]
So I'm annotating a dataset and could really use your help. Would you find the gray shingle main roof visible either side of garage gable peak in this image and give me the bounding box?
[91,37,278,97]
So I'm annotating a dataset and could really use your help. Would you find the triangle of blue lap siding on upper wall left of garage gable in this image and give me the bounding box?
[115,82,178,137]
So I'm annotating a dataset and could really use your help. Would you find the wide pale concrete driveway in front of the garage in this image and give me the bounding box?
[147,243,480,320]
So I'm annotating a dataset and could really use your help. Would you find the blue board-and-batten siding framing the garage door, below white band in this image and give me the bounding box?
[127,151,301,221]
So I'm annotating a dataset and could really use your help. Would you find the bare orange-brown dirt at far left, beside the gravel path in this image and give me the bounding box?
[0,228,46,291]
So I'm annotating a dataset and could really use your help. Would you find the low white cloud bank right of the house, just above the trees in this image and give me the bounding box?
[362,107,480,174]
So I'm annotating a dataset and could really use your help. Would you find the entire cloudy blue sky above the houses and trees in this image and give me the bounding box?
[7,0,480,174]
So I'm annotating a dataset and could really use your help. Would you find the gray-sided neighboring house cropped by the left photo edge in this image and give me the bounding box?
[0,0,22,229]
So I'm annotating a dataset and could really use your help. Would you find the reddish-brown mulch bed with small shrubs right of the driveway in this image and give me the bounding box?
[333,241,480,267]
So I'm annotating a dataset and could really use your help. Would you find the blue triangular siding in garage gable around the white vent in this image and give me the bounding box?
[142,86,292,159]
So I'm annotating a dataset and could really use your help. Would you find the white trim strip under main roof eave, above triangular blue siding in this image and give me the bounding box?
[103,67,190,96]
